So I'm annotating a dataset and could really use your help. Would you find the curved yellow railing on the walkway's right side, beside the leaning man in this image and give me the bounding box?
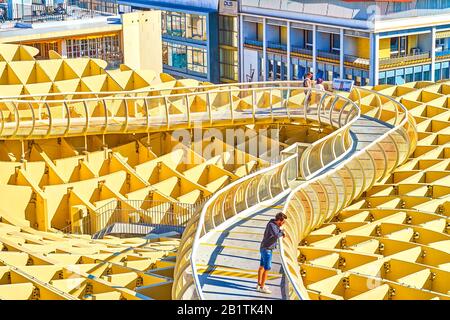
[281,89,417,298]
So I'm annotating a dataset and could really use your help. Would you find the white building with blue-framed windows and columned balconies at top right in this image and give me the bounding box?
[239,0,450,85]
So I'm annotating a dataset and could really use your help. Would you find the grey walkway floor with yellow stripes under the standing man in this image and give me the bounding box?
[197,116,391,300]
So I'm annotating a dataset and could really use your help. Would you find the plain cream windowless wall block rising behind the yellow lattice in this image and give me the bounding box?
[122,11,162,73]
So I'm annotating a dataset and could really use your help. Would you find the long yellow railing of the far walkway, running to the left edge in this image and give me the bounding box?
[0,82,350,139]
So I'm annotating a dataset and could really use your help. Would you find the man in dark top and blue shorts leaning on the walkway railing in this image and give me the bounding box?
[256,212,287,294]
